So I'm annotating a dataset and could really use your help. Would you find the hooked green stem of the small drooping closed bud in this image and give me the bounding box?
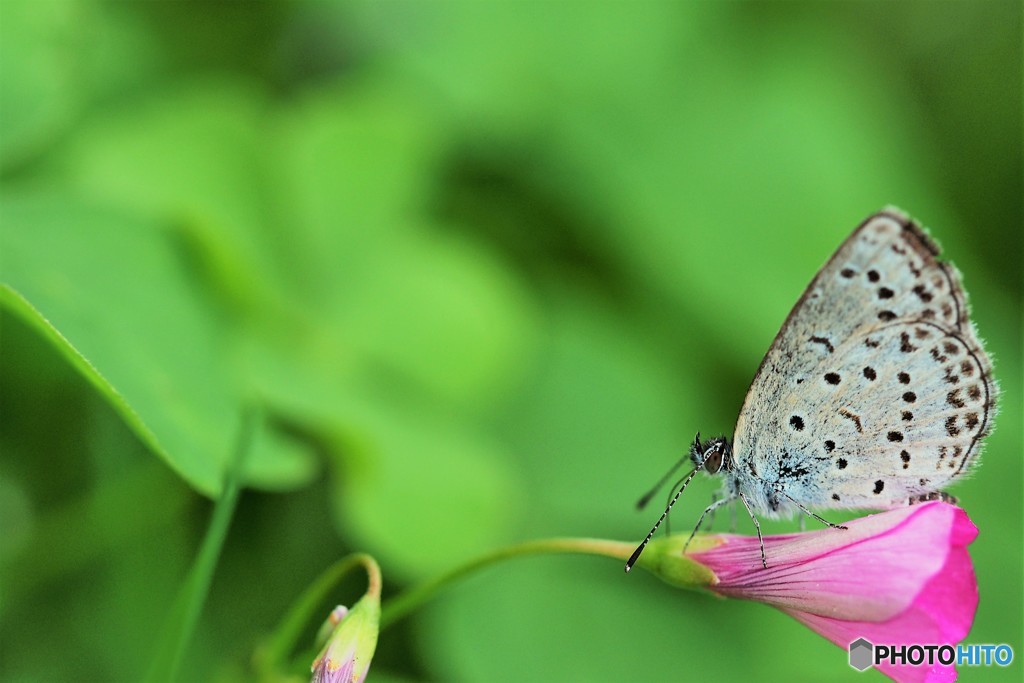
[255,553,381,680]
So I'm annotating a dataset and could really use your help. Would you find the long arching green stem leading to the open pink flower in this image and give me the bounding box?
[381,539,634,630]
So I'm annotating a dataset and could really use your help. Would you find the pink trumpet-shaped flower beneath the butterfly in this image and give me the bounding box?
[689,502,978,682]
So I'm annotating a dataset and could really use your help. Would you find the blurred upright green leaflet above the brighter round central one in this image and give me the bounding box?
[267,79,449,264]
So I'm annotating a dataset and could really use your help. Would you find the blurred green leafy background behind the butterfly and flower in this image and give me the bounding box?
[0,0,1024,681]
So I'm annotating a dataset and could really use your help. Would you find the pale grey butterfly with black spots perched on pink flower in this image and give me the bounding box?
[626,208,997,571]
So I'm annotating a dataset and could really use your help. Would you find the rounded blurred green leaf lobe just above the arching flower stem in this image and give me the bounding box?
[333,405,523,578]
